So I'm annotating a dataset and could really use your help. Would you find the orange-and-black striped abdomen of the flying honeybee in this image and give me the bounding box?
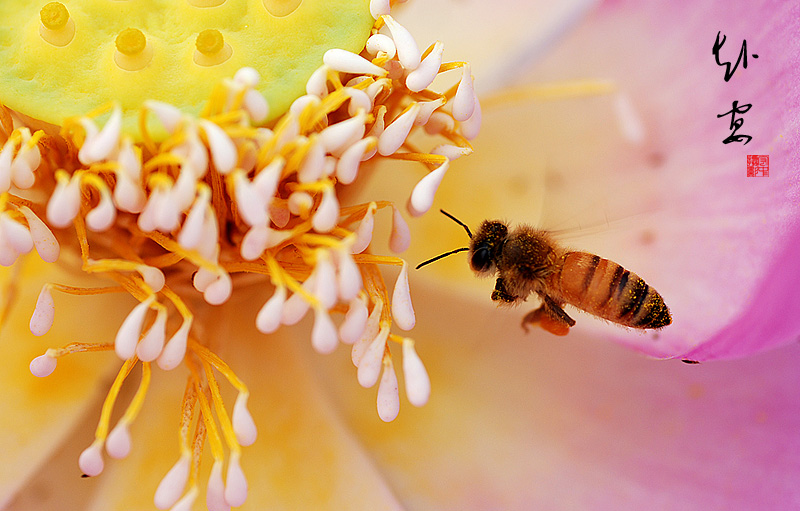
[549,252,672,328]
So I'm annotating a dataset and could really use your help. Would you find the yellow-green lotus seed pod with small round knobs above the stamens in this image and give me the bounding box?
[0,0,374,136]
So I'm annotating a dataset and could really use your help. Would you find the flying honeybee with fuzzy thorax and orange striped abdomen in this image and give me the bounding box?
[417,210,672,335]
